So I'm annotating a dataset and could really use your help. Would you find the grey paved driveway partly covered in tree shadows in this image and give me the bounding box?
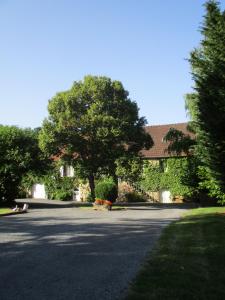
[0,206,184,300]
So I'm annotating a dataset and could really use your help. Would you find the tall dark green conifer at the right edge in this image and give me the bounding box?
[186,1,225,202]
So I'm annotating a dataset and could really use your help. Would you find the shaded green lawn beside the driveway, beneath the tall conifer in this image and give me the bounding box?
[126,207,225,300]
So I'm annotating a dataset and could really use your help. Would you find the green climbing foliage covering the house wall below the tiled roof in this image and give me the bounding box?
[140,157,198,197]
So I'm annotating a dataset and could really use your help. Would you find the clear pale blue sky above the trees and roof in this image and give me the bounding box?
[0,0,225,127]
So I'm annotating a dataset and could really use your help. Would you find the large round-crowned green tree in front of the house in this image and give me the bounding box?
[40,76,153,198]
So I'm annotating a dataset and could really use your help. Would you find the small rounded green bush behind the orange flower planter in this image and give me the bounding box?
[95,179,118,202]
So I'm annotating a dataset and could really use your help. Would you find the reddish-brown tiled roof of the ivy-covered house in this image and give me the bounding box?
[141,123,192,159]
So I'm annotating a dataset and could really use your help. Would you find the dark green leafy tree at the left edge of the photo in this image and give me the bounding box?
[0,125,50,202]
